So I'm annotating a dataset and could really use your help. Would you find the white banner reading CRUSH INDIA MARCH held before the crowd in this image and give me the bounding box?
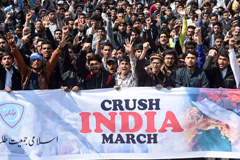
[0,88,240,160]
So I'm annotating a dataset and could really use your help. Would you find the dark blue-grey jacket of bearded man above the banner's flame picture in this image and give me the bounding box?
[175,67,209,88]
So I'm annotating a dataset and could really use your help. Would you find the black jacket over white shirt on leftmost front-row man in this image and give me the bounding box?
[0,66,22,90]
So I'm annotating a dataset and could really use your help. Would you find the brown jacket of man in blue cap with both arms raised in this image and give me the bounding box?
[10,44,61,90]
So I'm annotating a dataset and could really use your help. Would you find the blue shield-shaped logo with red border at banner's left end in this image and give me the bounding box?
[0,102,26,130]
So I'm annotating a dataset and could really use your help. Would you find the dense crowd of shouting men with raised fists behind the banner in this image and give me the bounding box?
[0,0,240,92]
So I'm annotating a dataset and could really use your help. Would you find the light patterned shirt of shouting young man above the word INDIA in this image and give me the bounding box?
[115,57,138,87]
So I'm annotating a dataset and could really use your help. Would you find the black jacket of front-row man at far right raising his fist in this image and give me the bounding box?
[203,56,236,88]
